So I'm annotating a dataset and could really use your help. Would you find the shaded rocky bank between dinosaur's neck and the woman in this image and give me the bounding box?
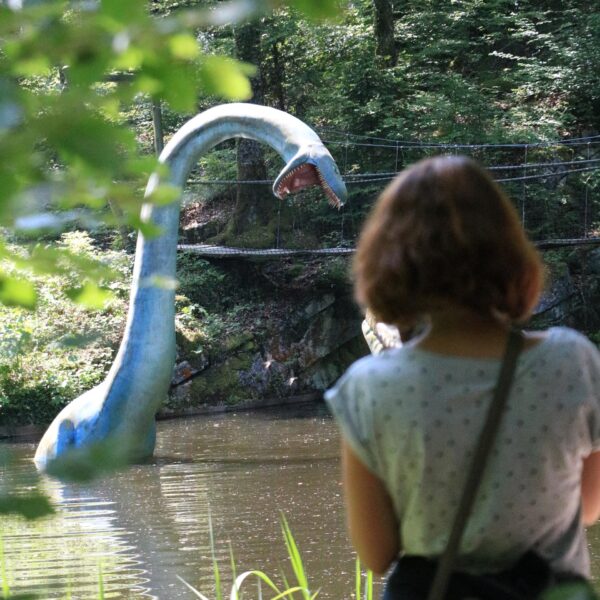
[167,280,368,412]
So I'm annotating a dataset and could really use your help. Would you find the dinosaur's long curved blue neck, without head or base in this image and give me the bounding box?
[103,104,319,428]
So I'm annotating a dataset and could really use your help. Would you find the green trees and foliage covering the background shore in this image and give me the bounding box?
[0,0,600,424]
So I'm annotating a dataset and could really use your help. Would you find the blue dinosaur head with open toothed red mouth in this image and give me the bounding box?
[273,143,347,208]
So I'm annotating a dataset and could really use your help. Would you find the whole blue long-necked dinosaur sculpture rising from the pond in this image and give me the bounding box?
[34,104,346,469]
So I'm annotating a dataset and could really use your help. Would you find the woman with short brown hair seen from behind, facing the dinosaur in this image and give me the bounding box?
[326,157,600,598]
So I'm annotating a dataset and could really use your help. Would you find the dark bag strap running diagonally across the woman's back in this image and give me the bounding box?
[427,329,524,600]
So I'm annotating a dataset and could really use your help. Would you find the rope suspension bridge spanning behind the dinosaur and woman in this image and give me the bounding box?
[178,128,600,261]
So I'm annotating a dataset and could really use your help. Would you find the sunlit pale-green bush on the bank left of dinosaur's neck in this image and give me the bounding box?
[0,231,132,425]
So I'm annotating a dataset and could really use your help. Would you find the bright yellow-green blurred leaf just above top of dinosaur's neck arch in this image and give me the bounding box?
[200,56,256,100]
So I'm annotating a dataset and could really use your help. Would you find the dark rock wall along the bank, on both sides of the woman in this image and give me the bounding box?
[167,244,600,412]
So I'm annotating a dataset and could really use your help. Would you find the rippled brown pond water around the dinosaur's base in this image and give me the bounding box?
[0,404,378,600]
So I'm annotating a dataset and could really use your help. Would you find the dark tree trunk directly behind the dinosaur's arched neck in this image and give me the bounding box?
[228,22,274,241]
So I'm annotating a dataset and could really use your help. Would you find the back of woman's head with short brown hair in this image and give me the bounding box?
[354,156,543,323]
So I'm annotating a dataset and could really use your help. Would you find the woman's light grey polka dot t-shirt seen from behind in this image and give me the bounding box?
[325,327,600,576]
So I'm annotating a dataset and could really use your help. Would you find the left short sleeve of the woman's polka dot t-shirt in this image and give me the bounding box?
[325,367,378,474]
